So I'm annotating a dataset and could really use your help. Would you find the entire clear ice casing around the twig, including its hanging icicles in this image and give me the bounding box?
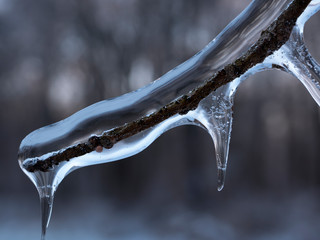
[19,0,320,239]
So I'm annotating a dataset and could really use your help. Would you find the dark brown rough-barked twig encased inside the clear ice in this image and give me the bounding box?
[19,0,311,172]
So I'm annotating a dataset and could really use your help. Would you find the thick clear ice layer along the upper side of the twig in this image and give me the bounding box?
[19,0,290,159]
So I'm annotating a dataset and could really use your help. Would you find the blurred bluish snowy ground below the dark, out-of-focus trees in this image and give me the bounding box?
[0,191,320,240]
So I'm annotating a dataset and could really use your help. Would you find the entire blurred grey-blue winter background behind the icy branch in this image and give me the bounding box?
[0,0,320,240]
